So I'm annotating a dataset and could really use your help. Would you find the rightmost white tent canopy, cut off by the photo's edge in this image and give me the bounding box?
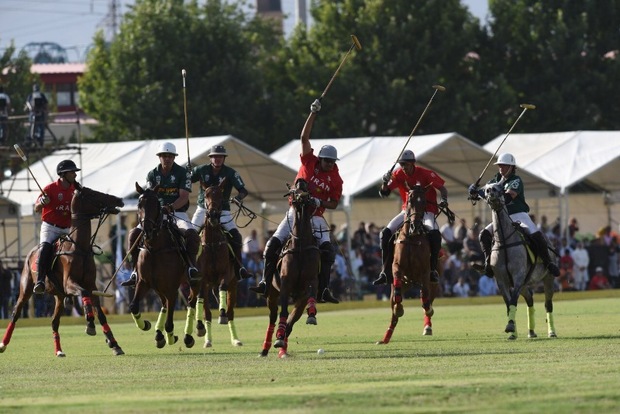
[484,131,620,193]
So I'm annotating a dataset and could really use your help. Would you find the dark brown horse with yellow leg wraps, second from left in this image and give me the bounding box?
[129,183,195,348]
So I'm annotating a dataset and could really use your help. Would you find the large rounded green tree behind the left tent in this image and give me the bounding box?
[80,0,279,149]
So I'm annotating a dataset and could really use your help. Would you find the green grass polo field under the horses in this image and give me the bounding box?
[0,291,620,414]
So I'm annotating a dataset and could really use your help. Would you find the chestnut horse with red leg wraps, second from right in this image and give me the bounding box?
[377,185,439,345]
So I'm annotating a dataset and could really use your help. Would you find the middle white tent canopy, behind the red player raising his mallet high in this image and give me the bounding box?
[271,132,553,197]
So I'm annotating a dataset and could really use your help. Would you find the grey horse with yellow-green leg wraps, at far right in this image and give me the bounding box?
[484,183,557,340]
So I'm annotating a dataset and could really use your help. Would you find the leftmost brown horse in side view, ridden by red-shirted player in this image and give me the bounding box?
[0,182,124,357]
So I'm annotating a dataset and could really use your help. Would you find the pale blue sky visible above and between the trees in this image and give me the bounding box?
[0,0,488,62]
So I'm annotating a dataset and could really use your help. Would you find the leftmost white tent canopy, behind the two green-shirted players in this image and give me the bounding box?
[2,135,296,216]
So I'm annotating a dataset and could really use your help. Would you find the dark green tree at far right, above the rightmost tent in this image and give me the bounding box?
[488,0,620,132]
